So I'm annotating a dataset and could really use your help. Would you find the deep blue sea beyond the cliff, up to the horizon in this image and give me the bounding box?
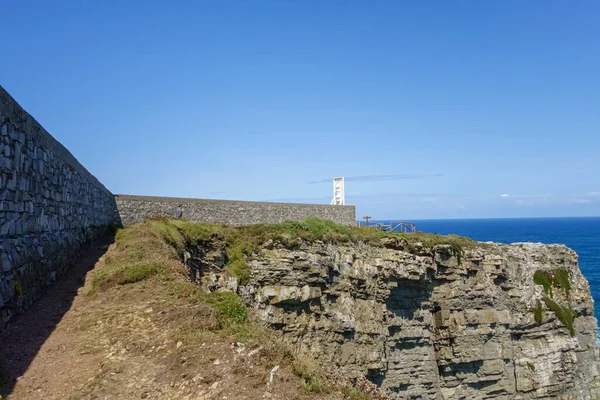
[382,217,600,324]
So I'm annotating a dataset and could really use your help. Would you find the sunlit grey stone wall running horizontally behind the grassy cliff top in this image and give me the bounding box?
[115,195,356,225]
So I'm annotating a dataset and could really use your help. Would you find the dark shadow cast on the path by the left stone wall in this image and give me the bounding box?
[0,235,114,396]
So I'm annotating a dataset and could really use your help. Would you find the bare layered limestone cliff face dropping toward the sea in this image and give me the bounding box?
[240,242,600,399]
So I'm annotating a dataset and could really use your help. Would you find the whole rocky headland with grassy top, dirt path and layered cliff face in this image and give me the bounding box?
[0,218,600,400]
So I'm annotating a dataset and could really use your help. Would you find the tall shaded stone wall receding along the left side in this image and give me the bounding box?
[0,86,120,329]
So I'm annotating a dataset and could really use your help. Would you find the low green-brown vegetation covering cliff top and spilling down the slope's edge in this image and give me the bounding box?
[88,218,426,400]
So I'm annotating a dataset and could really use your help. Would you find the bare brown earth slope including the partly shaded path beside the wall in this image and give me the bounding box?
[0,239,346,400]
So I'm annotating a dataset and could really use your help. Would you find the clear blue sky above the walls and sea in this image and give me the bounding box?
[0,0,600,219]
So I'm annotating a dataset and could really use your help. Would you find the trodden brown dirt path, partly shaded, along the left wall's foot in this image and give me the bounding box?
[0,239,110,399]
